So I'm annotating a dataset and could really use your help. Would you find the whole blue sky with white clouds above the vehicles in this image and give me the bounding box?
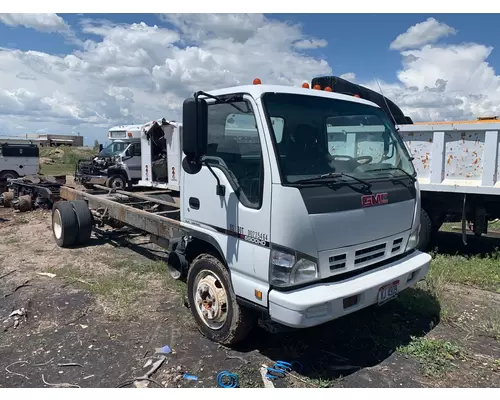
[0,14,500,140]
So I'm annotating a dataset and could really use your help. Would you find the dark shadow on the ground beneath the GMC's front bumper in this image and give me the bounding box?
[232,289,440,381]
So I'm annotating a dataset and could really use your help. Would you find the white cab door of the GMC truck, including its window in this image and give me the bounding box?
[181,96,271,305]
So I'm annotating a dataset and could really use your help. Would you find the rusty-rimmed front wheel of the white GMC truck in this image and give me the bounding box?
[187,254,254,346]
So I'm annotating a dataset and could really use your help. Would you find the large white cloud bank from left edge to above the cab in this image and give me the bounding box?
[0,14,331,140]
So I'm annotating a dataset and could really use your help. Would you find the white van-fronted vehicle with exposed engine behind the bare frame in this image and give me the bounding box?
[75,125,143,189]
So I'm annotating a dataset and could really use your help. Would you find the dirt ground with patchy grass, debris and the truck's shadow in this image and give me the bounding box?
[0,208,500,387]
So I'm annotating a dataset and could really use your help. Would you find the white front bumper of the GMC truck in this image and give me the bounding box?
[269,251,432,328]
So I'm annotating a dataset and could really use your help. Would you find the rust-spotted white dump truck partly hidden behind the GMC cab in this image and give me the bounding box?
[312,77,500,251]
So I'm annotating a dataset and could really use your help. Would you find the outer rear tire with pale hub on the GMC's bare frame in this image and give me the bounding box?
[52,200,78,247]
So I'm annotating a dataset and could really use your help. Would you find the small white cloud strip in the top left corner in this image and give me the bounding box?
[0,13,70,33]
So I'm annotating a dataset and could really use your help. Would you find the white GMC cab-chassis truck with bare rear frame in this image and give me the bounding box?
[47,79,431,345]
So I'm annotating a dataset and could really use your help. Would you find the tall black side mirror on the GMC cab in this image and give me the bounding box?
[182,97,208,174]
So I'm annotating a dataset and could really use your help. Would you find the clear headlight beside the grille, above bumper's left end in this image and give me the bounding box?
[270,249,319,287]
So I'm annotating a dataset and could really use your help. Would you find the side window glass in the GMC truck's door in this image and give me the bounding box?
[205,100,264,209]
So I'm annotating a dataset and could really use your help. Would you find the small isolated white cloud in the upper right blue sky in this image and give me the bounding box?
[390,18,457,50]
